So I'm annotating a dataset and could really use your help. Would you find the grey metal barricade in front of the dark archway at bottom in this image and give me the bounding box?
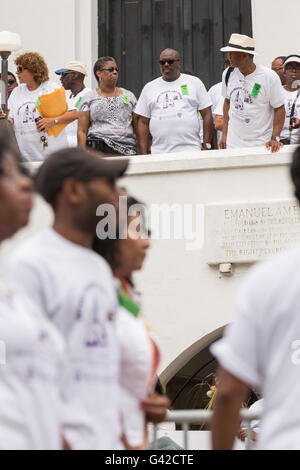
[152,409,261,450]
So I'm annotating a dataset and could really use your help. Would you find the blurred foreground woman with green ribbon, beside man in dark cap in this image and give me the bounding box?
[94,192,170,450]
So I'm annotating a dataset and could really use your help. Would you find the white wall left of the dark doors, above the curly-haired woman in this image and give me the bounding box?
[0,0,98,86]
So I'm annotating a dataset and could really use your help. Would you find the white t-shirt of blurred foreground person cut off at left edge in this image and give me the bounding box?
[0,264,64,450]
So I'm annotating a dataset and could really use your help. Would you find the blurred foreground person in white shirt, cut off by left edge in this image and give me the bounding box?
[0,139,64,450]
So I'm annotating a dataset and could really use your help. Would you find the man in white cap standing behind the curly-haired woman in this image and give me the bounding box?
[55,60,92,147]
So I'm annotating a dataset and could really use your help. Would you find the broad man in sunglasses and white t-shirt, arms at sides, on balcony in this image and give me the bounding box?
[135,49,213,155]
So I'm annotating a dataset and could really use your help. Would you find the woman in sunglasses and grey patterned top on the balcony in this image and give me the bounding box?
[78,57,137,156]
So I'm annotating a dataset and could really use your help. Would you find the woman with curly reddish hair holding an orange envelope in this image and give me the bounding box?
[8,52,77,161]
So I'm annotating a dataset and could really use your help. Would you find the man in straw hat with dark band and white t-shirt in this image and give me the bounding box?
[220,34,285,152]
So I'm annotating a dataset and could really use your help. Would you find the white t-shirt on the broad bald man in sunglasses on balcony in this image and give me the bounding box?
[135,73,211,154]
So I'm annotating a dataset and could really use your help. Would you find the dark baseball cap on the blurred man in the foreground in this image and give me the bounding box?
[35,147,129,206]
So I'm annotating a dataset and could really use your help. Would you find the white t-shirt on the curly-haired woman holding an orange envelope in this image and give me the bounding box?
[8,81,68,162]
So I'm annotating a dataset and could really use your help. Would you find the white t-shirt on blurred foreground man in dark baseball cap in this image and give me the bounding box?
[13,229,120,450]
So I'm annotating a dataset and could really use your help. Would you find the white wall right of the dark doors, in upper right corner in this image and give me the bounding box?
[252,0,300,67]
